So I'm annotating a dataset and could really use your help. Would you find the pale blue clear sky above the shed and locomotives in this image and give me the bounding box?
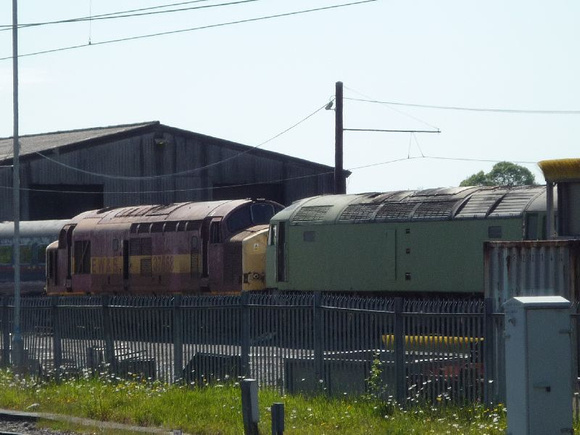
[0,0,580,193]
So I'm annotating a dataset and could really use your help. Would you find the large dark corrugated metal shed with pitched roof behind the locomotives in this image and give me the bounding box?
[0,121,340,220]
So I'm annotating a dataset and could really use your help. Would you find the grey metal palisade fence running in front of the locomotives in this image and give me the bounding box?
[0,293,560,403]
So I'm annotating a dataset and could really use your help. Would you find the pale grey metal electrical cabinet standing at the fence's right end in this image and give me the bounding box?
[504,296,573,435]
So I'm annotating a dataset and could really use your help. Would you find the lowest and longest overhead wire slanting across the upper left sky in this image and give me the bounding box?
[0,0,379,61]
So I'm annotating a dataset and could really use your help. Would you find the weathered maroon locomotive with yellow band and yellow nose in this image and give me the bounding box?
[46,199,282,294]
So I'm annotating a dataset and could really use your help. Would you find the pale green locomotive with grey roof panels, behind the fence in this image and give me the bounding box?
[266,186,547,295]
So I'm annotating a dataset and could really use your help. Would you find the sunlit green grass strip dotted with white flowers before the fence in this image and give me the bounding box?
[0,370,506,435]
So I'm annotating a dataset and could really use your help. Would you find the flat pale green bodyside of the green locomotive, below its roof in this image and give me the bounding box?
[267,219,522,293]
